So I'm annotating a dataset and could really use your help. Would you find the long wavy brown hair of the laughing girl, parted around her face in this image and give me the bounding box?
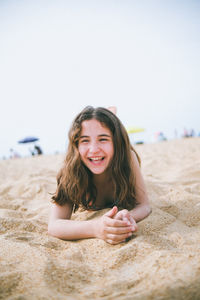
[52,106,140,209]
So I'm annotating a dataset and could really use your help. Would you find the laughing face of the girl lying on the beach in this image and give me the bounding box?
[78,119,114,175]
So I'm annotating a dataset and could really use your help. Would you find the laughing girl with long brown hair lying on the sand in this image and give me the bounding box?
[48,106,151,244]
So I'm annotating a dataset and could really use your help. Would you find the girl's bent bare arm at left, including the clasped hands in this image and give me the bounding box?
[48,203,133,244]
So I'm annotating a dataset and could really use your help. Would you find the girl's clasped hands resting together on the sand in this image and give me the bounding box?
[95,206,135,245]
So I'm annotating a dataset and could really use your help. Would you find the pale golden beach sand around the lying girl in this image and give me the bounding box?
[0,138,200,300]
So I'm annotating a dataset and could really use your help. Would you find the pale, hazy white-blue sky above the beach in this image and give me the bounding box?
[0,0,200,158]
